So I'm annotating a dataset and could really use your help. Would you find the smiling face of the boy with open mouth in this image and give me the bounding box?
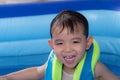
[48,24,93,72]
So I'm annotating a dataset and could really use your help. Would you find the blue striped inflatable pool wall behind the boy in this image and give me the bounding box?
[0,0,120,76]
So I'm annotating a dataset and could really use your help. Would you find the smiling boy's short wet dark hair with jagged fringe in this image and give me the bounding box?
[50,10,89,38]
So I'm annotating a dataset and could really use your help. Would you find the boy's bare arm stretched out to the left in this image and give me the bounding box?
[0,64,46,80]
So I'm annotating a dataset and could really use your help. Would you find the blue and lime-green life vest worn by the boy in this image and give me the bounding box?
[44,40,100,80]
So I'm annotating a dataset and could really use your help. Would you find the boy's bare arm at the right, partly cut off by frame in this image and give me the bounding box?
[95,62,120,80]
